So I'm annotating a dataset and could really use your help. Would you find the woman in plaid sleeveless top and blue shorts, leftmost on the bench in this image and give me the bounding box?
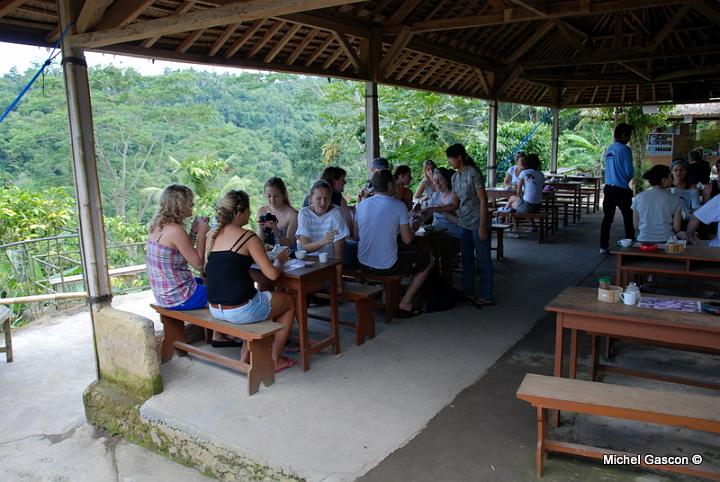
[145,184,209,310]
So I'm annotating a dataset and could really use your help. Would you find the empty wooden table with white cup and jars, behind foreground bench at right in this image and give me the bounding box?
[545,286,720,389]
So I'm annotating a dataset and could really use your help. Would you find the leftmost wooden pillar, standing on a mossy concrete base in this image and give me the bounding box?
[58,0,112,306]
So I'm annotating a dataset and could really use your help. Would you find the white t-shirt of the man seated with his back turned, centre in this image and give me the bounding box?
[355,194,410,269]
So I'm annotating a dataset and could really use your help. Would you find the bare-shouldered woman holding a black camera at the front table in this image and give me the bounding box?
[257,177,297,249]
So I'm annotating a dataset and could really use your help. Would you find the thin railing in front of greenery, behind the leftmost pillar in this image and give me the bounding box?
[0,233,149,324]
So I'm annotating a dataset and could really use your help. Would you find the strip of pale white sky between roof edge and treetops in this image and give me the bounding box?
[0,42,241,75]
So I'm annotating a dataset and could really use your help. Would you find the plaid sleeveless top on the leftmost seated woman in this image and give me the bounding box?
[145,241,197,308]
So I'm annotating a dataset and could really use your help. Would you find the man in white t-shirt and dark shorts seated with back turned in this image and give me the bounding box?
[355,170,433,318]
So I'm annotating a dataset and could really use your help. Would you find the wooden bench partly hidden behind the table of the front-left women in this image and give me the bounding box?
[311,281,382,346]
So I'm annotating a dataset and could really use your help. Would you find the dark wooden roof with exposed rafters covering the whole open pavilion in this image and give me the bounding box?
[0,0,720,107]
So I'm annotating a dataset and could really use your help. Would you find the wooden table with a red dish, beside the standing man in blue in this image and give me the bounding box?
[610,245,720,286]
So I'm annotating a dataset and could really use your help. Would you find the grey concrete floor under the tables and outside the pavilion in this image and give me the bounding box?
[0,209,720,482]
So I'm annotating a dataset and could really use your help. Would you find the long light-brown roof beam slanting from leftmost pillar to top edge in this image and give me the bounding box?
[70,0,365,48]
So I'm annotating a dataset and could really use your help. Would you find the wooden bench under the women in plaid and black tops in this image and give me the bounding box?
[150,305,282,395]
